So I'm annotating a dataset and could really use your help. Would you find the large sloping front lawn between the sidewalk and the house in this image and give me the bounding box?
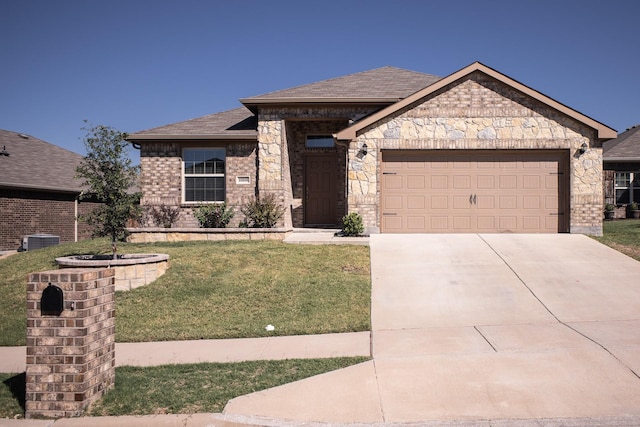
[0,239,371,346]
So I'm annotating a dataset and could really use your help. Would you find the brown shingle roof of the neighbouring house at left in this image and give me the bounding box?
[0,129,83,193]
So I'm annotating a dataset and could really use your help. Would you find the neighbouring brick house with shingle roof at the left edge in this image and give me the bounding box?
[0,130,95,250]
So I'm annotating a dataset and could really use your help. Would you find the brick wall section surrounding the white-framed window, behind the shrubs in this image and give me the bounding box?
[140,141,257,227]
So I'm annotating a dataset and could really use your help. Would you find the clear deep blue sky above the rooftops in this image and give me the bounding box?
[0,0,640,162]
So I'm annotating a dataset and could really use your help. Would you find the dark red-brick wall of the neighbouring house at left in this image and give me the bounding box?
[0,189,96,250]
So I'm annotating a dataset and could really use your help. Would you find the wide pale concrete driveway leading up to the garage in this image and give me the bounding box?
[224,234,640,426]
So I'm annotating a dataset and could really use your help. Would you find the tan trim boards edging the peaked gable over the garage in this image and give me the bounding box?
[335,62,616,140]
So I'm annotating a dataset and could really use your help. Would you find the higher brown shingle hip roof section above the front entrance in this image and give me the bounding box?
[240,66,440,105]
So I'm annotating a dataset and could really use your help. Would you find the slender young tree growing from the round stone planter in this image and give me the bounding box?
[76,120,141,258]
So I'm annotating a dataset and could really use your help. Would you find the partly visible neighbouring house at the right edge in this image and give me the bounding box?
[603,125,640,209]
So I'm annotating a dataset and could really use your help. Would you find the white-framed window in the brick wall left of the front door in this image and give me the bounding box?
[182,148,226,203]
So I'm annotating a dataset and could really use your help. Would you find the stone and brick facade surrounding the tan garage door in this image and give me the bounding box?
[348,72,603,235]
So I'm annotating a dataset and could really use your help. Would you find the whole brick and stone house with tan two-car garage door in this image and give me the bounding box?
[128,62,616,234]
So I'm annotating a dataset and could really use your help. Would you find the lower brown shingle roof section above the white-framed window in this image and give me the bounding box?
[127,107,258,141]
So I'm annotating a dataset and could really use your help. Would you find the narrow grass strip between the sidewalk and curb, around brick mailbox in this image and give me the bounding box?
[0,357,367,418]
